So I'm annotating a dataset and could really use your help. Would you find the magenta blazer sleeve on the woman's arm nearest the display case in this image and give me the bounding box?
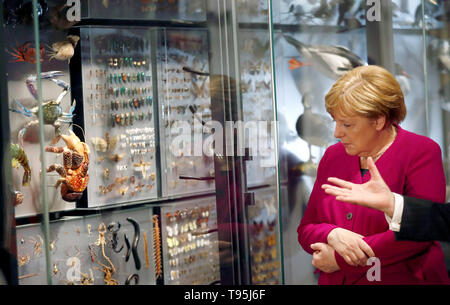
[297,151,338,255]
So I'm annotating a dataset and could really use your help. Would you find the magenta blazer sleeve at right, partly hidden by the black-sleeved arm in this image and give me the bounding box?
[335,143,445,273]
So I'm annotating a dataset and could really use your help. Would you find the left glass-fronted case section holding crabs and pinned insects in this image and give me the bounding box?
[1,0,283,285]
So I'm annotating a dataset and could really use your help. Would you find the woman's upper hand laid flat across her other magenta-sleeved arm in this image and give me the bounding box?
[327,228,375,267]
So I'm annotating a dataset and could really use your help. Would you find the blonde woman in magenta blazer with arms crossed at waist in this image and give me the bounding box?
[297,66,449,284]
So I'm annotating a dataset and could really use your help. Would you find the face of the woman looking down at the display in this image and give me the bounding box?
[333,114,384,157]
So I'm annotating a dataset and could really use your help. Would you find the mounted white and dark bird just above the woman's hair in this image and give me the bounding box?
[284,35,367,80]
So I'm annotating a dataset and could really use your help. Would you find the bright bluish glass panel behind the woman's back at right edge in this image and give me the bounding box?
[392,0,450,270]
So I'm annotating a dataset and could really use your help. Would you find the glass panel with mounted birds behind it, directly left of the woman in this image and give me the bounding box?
[273,1,368,284]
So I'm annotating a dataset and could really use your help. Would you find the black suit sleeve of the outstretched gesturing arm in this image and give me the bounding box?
[394,196,450,241]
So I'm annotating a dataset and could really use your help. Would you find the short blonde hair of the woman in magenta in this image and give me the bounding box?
[325,65,406,125]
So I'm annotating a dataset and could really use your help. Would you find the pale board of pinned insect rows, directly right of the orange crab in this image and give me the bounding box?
[81,27,159,207]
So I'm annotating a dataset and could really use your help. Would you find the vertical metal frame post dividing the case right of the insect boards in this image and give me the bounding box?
[207,0,251,285]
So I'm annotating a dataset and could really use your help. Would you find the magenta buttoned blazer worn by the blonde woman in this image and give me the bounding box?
[297,126,450,285]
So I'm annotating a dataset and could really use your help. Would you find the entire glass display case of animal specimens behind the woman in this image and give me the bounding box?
[0,0,450,285]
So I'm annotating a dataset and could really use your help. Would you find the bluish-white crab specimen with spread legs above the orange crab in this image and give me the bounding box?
[10,71,76,146]
